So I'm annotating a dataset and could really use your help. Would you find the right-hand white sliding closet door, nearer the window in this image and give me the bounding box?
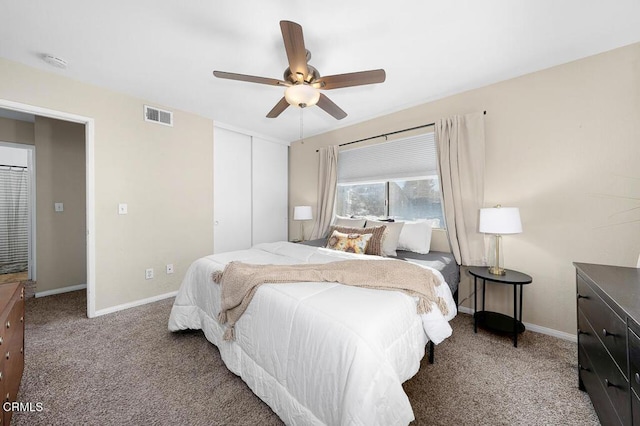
[251,137,289,244]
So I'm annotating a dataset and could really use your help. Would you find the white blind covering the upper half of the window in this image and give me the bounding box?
[338,132,438,183]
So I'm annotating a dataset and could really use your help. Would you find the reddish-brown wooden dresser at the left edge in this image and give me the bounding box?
[0,283,24,426]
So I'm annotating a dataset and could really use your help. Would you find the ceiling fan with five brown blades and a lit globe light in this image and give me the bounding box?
[213,21,386,120]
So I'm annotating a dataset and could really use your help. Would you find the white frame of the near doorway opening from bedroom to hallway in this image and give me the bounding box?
[0,99,96,318]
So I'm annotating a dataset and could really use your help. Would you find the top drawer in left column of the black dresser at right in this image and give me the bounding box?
[577,275,627,377]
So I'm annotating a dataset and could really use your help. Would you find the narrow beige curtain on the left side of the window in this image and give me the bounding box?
[311,145,338,240]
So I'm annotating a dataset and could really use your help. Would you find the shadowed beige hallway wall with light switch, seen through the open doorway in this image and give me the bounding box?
[34,117,87,292]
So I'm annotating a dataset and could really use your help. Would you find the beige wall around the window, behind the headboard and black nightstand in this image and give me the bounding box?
[289,44,640,334]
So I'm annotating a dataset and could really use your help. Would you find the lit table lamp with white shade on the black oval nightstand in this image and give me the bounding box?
[479,204,522,275]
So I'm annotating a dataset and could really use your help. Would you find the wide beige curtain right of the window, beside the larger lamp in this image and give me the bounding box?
[435,113,484,265]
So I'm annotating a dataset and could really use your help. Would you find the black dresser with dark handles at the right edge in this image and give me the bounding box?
[574,263,640,425]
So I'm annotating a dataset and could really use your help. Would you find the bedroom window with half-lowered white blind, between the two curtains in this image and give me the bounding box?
[336,133,444,228]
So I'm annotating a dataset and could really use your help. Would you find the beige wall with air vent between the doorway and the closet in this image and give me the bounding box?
[0,59,213,311]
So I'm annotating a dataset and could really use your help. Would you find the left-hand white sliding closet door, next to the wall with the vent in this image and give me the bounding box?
[213,127,252,253]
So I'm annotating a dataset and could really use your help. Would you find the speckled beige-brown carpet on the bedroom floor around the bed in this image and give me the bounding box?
[12,291,598,426]
